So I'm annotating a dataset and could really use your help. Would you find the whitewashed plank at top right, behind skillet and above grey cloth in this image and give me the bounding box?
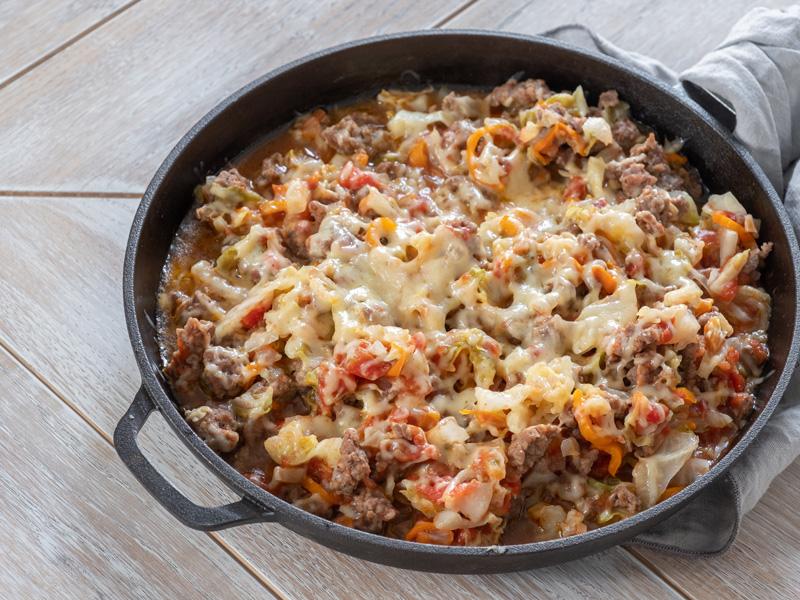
[447,0,793,71]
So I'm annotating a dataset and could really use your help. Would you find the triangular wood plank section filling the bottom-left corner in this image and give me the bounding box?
[0,349,268,599]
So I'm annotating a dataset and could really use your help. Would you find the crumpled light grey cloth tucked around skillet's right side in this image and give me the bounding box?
[544,5,800,555]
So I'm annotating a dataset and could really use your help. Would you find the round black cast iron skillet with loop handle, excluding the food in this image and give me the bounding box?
[114,31,800,573]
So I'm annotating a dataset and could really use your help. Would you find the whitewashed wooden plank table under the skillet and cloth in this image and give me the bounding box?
[0,0,800,599]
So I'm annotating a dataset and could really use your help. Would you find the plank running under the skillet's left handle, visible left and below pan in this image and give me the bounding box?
[0,198,675,599]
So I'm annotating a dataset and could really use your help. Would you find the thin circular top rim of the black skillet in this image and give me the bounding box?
[123,29,800,570]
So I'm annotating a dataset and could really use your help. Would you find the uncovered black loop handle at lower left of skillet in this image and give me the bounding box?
[114,388,276,531]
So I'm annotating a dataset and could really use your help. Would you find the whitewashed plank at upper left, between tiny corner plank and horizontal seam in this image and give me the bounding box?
[0,0,462,192]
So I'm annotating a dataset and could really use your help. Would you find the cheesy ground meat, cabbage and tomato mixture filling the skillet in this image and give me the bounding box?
[160,80,770,545]
